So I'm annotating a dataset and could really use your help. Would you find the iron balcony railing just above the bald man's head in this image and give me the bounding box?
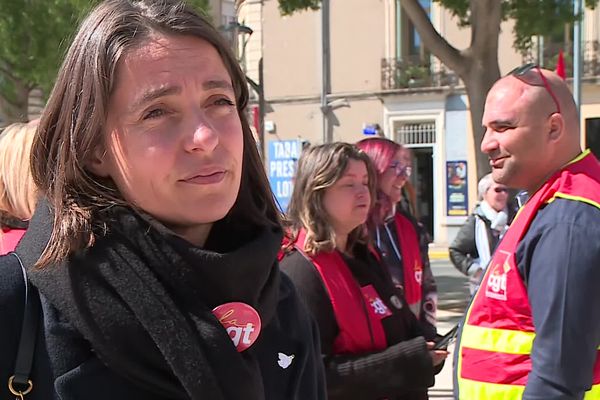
[522,40,600,78]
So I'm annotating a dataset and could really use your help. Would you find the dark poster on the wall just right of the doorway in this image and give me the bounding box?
[446,161,469,217]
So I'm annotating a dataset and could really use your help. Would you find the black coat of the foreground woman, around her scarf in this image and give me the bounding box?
[0,202,326,400]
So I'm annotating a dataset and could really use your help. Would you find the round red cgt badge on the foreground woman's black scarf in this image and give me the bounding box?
[213,302,261,352]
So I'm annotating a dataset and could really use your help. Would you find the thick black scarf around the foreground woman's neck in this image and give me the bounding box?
[19,205,281,399]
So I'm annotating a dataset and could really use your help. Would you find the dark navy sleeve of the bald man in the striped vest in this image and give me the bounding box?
[516,199,600,400]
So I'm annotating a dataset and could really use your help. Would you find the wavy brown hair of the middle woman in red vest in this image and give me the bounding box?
[286,142,375,255]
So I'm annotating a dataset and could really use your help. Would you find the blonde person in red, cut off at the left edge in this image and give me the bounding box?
[0,122,38,255]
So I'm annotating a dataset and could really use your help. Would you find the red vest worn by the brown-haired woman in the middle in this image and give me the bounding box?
[295,230,391,354]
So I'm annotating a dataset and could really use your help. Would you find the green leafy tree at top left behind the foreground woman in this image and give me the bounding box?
[0,0,209,123]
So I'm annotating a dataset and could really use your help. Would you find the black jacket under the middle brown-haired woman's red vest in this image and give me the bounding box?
[281,246,434,400]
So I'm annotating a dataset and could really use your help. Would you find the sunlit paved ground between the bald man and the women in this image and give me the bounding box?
[429,259,469,400]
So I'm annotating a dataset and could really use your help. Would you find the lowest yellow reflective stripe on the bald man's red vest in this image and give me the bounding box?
[458,378,600,400]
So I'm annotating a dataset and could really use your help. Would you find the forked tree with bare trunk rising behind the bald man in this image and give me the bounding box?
[279,0,598,178]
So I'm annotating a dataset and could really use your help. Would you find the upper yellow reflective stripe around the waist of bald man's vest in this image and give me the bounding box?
[460,324,535,354]
